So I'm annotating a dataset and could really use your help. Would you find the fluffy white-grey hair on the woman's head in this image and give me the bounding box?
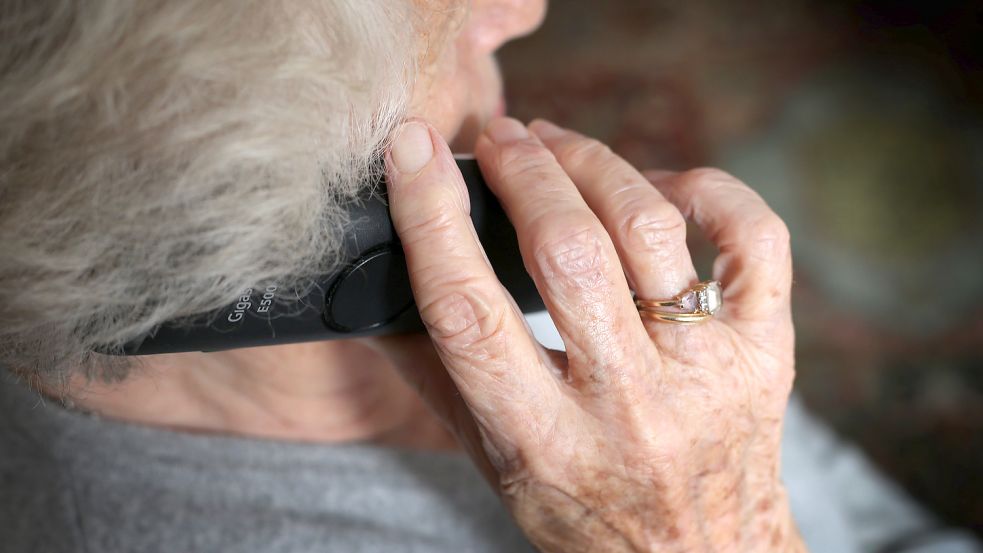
[0,0,417,378]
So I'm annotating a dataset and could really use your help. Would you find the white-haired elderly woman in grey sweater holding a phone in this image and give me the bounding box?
[0,0,980,552]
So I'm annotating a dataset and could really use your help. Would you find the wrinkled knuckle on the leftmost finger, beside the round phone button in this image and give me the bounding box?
[420,282,507,360]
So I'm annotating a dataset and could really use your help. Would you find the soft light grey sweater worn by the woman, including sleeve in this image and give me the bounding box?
[0,368,979,553]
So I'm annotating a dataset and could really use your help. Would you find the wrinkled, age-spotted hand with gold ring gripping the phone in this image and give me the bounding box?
[372,118,804,552]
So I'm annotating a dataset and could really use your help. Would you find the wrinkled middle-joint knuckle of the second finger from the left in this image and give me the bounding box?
[534,227,607,289]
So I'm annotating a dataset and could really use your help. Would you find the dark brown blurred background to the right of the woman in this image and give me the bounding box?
[501,0,983,535]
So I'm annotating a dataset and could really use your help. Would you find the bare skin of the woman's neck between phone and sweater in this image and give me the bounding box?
[69,341,454,449]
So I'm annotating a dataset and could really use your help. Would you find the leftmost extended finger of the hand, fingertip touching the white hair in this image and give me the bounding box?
[387,121,557,439]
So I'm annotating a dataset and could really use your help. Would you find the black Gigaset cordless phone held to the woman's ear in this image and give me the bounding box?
[124,158,543,355]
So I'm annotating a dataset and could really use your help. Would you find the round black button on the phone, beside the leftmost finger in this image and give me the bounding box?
[324,245,413,333]
